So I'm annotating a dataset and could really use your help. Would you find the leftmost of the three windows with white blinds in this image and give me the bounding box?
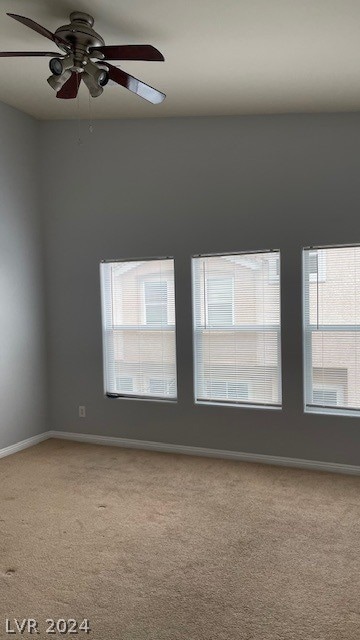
[100,258,177,400]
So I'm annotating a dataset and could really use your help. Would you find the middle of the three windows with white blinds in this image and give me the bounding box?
[192,251,281,407]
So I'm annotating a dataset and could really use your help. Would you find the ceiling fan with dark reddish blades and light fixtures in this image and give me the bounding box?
[0,11,166,104]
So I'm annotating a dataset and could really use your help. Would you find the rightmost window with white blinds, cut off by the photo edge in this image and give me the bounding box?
[303,246,360,415]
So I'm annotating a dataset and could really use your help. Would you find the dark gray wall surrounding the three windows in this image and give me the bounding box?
[41,115,360,464]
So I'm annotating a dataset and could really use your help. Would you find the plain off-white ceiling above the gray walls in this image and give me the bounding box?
[0,0,360,119]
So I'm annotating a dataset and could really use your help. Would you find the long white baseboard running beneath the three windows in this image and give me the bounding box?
[46,431,360,475]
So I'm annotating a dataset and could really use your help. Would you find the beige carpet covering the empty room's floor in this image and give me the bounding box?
[0,440,360,640]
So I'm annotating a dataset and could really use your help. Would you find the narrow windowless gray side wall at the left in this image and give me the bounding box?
[0,104,47,449]
